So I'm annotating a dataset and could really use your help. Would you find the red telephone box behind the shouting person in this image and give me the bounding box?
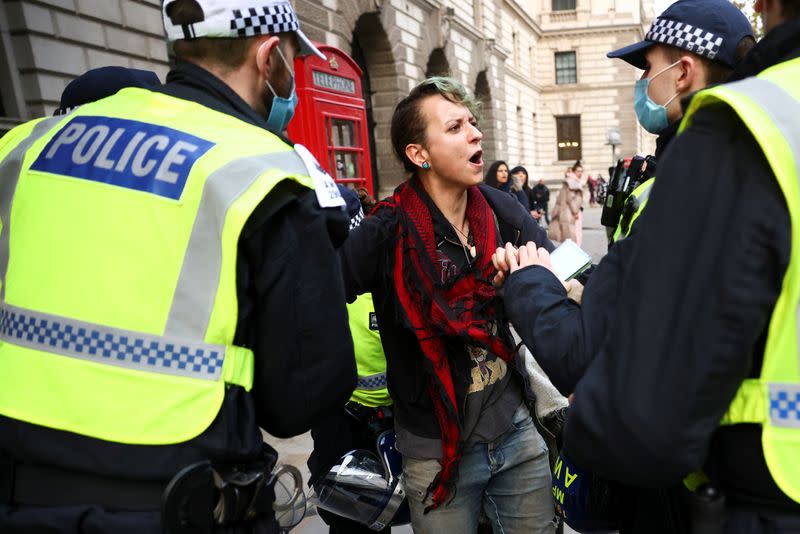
[287,43,374,196]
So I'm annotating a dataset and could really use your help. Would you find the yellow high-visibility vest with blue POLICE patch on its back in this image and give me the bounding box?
[0,88,313,445]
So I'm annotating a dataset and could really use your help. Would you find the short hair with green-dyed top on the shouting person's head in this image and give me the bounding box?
[391,76,481,174]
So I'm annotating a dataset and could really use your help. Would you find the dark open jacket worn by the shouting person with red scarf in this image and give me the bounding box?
[340,184,553,439]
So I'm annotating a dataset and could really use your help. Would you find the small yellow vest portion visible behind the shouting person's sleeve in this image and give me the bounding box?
[347,293,392,408]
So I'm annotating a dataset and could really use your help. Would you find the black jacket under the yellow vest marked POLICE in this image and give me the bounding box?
[0,64,356,532]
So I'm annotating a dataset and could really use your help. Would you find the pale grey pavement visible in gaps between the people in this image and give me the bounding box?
[264,207,607,534]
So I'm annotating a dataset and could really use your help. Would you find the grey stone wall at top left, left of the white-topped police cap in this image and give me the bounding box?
[0,0,168,131]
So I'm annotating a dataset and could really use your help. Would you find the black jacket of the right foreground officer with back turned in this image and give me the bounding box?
[564,20,800,513]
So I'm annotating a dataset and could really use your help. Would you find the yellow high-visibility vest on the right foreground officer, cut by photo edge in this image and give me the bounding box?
[681,59,800,502]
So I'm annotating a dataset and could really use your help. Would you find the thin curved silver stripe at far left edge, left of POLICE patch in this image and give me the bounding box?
[0,117,65,302]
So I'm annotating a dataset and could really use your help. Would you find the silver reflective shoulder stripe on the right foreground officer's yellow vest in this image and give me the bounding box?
[727,77,800,374]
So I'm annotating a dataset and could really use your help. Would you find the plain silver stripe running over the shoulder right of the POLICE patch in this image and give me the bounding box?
[164,151,308,339]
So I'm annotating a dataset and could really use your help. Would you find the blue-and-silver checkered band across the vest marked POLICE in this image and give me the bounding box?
[0,304,225,381]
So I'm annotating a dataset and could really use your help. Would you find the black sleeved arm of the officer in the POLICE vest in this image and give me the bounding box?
[240,191,356,437]
